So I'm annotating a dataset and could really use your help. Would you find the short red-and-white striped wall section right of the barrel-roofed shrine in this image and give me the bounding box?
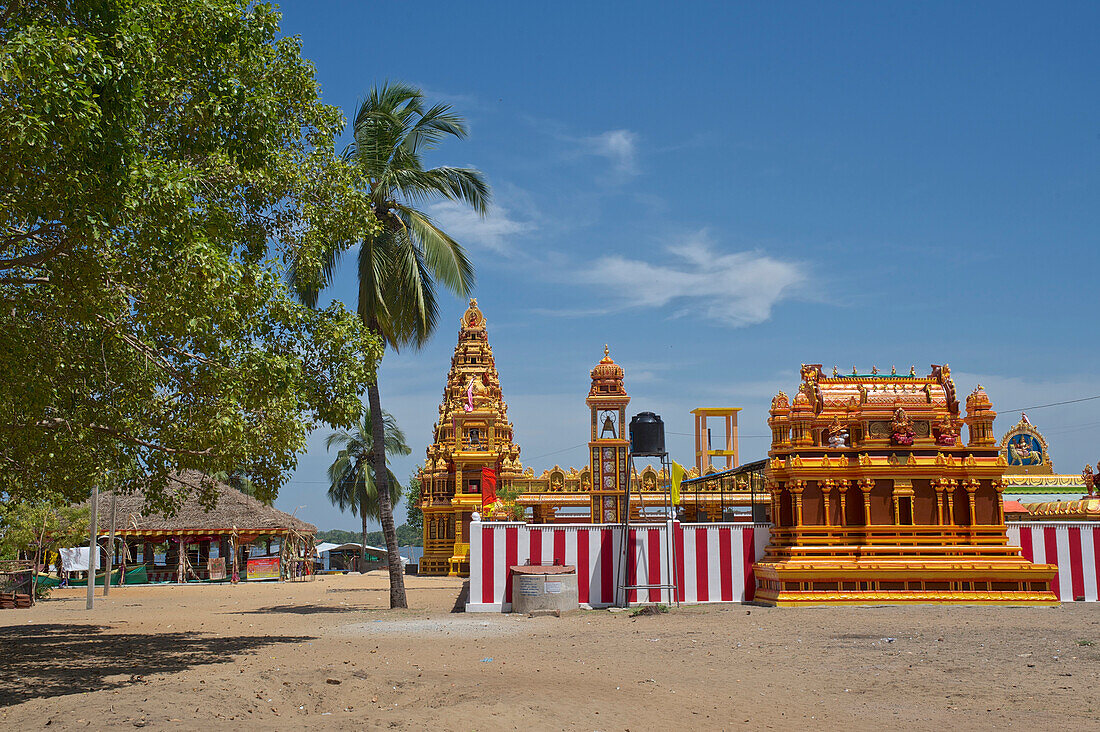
[1009,522,1100,602]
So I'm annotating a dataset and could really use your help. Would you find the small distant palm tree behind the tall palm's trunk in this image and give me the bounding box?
[325,412,413,568]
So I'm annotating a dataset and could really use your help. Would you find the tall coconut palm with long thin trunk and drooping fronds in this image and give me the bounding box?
[289,84,490,608]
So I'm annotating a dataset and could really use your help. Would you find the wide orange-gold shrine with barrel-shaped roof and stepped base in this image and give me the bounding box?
[755,364,1057,605]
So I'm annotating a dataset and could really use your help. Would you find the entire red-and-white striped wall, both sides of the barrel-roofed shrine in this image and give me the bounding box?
[466,522,1100,612]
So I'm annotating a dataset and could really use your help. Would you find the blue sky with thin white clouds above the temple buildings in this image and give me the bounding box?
[268,1,1100,528]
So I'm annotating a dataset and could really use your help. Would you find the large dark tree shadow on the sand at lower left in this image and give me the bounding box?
[0,623,315,707]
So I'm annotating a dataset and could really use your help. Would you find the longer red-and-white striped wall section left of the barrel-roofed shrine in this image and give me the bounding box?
[466,522,769,612]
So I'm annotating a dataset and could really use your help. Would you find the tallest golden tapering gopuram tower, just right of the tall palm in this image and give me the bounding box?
[420,299,523,576]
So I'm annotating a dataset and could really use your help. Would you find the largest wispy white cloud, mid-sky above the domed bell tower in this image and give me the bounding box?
[579,230,806,328]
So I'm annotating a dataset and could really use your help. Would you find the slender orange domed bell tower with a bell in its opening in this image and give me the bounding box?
[584,346,630,524]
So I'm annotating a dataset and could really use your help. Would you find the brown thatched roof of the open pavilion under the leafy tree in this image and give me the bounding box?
[86,471,317,540]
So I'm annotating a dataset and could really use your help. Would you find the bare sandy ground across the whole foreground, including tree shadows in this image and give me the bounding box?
[0,575,1100,730]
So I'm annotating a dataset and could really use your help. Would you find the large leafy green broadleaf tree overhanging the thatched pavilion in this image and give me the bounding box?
[0,0,382,510]
